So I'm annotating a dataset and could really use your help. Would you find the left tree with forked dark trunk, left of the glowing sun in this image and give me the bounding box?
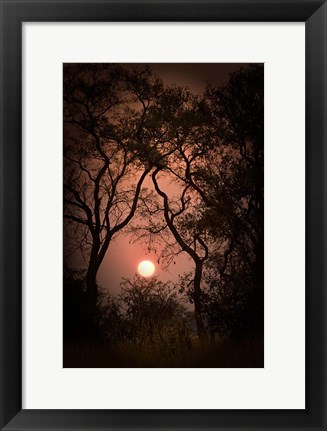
[64,64,172,308]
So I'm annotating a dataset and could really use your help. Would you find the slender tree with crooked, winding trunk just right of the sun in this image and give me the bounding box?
[133,93,215,337]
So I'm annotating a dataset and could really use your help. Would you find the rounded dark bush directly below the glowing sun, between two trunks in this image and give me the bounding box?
[98,276,191,352]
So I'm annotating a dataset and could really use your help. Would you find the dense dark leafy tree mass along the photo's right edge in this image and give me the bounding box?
[195,65,264,340]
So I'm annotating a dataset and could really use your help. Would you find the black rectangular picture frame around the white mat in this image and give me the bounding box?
[0,0,327,431]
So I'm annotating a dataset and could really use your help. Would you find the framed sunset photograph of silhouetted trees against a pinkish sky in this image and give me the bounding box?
[62,63,265,368]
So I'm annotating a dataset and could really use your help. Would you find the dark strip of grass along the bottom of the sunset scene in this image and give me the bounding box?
[63,338,264,368]
